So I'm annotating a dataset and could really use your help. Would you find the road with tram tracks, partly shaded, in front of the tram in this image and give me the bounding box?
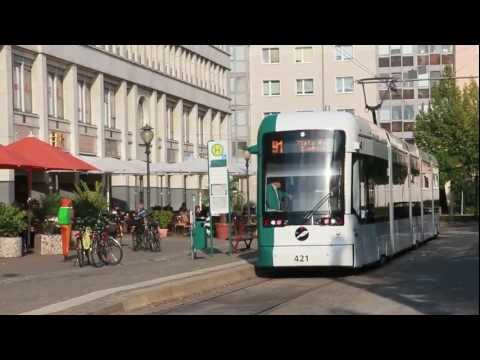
[144,223,479,315]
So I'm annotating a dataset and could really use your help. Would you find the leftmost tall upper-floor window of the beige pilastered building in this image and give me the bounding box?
[13,61,32,113]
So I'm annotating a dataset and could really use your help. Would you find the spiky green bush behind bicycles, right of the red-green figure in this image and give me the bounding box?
[73,181,108,218]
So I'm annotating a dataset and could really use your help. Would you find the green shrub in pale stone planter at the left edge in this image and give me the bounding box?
[0,203,27,258]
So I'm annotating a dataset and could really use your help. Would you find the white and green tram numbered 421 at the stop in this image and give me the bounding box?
[250,112,440,268]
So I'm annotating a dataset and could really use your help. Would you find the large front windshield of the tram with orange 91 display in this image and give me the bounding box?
[263,130,345,219]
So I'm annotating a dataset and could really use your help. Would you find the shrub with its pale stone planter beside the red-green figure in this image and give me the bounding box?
[32,194,62,255]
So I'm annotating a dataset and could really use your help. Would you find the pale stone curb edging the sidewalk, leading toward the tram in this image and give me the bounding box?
[89,263,256,315]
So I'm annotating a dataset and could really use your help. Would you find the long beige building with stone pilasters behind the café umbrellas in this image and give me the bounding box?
[0,45,230,208]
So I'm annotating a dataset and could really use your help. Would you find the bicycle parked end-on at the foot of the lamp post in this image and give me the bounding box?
[132,210,162,252]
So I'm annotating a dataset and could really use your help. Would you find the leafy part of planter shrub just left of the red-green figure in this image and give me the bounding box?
[32,193,62,235]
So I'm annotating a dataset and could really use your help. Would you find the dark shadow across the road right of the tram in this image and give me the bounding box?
[338,228,479,315]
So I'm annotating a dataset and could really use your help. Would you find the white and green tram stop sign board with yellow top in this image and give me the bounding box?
[208,140,230,216]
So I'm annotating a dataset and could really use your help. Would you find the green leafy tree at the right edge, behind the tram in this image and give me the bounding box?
[415,67,479,213]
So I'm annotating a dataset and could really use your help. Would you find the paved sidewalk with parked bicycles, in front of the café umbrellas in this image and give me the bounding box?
[0,236,256,314]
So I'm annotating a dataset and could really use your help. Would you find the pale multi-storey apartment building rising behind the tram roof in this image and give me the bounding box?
[230,45,478,204]
